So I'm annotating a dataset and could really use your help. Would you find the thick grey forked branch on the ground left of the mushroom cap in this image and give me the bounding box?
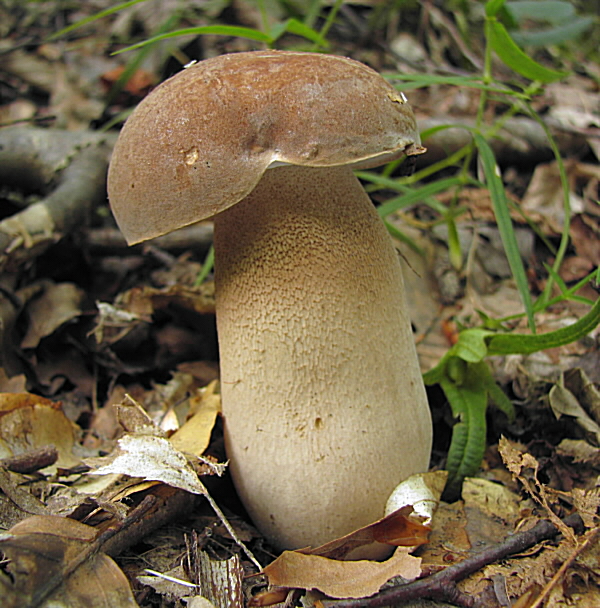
[0,127,114,273]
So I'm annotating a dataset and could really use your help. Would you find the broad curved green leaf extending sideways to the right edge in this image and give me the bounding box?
[488,299,600,355]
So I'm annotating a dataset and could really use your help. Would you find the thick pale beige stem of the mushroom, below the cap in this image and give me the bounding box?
[214,166,431,548]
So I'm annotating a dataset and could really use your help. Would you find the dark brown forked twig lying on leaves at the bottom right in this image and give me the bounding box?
[323,513,583,608]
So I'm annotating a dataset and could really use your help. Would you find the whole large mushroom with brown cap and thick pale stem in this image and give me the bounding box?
[108,51,432,548]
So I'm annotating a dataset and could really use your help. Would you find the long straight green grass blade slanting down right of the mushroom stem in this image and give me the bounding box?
[473,131,535,333]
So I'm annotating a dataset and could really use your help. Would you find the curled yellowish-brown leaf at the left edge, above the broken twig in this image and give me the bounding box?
[0,393,80,471]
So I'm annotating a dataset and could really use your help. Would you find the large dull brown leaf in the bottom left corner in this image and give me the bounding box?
[0,516,137,608]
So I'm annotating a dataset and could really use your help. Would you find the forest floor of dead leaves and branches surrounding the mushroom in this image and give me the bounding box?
[0,0,600,608]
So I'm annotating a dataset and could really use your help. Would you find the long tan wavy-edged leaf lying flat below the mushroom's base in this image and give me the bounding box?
[263,548,421,598]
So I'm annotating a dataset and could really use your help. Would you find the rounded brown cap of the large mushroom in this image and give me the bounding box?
[108,51,424,244]
